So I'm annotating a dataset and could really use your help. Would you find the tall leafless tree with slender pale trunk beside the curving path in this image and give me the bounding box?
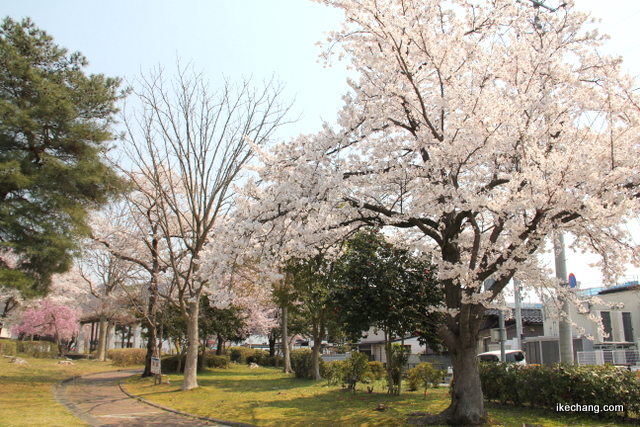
[125,67,288,390]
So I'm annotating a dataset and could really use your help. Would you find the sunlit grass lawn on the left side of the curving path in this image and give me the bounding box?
[0,357,127,427]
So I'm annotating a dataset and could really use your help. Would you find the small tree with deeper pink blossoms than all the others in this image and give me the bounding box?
[13,300,78,354]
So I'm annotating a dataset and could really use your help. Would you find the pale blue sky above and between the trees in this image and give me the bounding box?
[5,0,640,285]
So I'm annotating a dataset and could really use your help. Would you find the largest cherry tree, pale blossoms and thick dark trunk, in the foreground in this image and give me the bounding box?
[242,0,640,425]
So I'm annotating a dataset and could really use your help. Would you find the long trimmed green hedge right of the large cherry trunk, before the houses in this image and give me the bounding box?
[479,362,640,419]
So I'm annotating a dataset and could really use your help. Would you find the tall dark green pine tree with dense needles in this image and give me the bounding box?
[0,18,122,294]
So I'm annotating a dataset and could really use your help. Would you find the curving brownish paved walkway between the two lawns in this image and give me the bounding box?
[54,371,248,427]
